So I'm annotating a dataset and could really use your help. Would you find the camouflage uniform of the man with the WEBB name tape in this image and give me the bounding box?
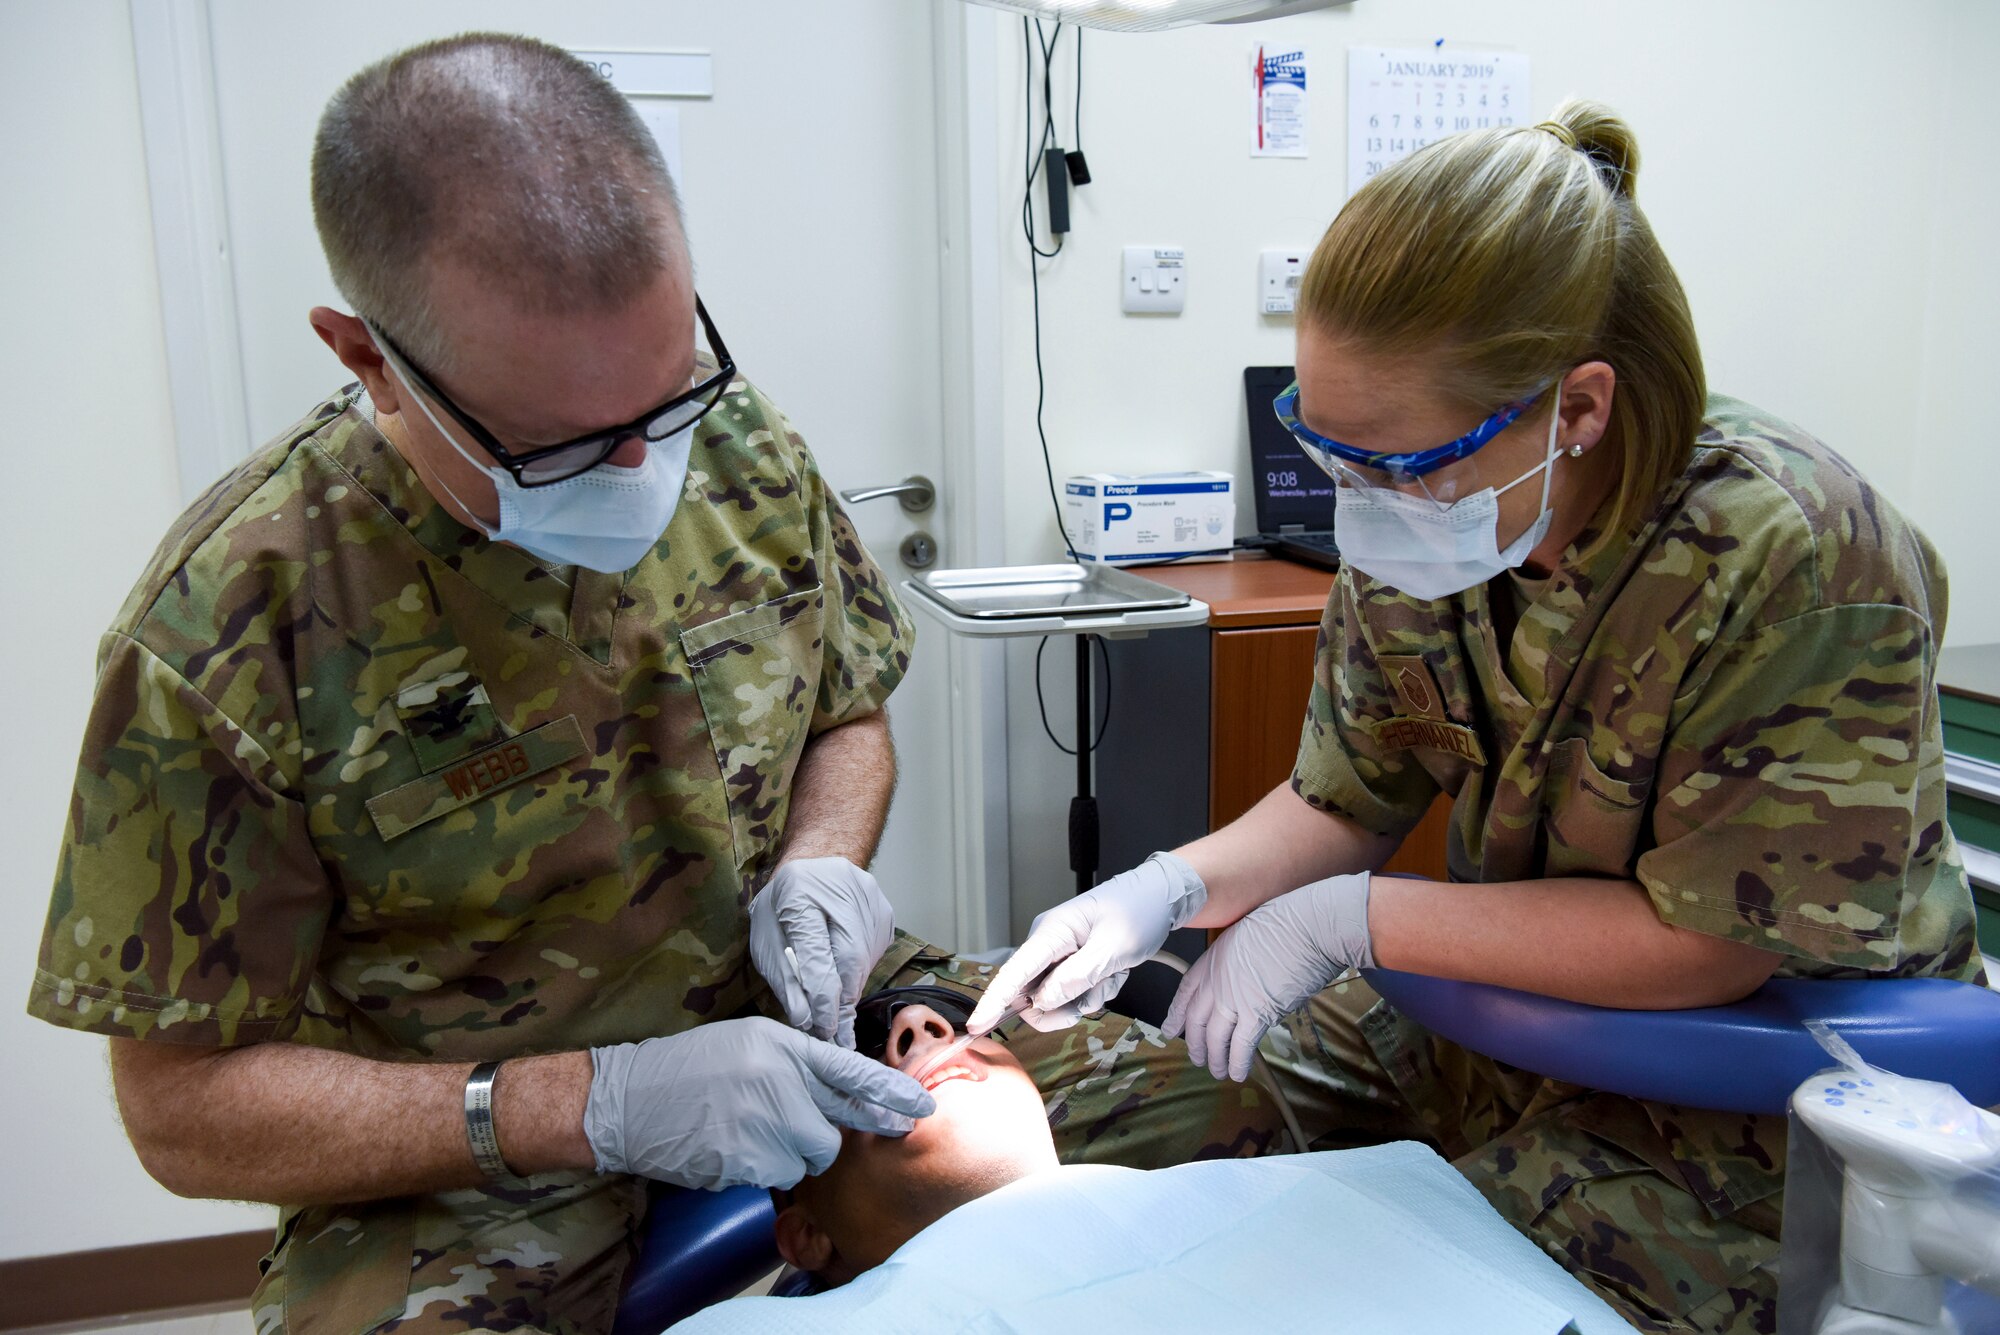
[30,382,1272,1333]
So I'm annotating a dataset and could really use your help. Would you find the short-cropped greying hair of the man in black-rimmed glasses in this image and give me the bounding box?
[312,32,686,370]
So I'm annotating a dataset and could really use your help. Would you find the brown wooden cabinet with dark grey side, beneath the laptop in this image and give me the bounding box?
[1098,558,1450,879]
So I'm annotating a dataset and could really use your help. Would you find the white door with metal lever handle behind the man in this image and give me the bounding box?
[199,0,964,945]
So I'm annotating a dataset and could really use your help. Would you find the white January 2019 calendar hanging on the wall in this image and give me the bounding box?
[1348,46,1528,194]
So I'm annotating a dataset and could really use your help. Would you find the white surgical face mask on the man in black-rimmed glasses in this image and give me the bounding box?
[384,358,696,576]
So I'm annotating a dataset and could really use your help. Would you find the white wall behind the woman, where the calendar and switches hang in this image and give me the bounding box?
[998,0,2000,931]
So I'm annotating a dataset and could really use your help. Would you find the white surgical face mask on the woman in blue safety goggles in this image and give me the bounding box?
[1334,395,1562,600]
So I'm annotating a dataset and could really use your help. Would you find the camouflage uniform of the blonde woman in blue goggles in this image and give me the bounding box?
[1270,400,1982,1331]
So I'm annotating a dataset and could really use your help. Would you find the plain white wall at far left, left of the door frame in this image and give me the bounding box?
[0,0,272,1259]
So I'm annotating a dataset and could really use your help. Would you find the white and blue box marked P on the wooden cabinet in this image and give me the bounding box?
[1062,472,1236,566]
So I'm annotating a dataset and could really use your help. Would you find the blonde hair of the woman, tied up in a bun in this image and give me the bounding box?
[1298,98,1708,538]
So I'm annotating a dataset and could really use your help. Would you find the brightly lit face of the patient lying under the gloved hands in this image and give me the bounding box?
[776,1005,1056,1283]
